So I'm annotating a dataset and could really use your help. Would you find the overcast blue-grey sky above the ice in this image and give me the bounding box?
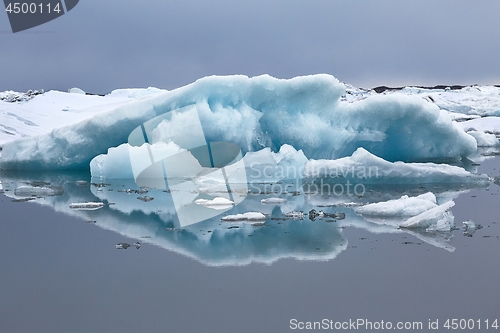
[0,0,500,93]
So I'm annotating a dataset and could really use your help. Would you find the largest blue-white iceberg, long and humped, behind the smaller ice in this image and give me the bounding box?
[0,74,477,170]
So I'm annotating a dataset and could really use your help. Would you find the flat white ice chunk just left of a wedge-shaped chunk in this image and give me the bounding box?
[354,192,437,218]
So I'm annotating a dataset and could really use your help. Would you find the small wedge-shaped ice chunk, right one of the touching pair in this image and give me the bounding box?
[400,201,455,231]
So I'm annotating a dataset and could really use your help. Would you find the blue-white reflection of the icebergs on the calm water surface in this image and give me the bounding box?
[0,172,487,266]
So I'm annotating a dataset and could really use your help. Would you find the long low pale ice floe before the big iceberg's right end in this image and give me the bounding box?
[304,148,490,185]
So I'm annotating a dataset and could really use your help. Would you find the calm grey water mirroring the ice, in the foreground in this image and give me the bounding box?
[0,157,500,332]
